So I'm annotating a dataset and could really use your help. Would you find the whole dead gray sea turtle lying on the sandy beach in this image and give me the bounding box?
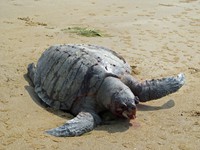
[28,44,185,136]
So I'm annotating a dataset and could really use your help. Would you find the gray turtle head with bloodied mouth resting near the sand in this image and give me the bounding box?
[97,77,138,119]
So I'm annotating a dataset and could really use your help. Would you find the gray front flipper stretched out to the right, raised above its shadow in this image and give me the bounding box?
[122,73,185,102]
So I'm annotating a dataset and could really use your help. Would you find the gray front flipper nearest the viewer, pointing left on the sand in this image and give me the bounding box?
[46,112,101,137]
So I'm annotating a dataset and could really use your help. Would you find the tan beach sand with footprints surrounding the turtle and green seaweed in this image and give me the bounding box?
[0,0,200,150]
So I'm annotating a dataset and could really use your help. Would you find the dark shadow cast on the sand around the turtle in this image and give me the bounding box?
[24,74,175,133]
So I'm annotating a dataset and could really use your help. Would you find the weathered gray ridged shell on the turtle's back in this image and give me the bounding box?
[34,45,131,110]
